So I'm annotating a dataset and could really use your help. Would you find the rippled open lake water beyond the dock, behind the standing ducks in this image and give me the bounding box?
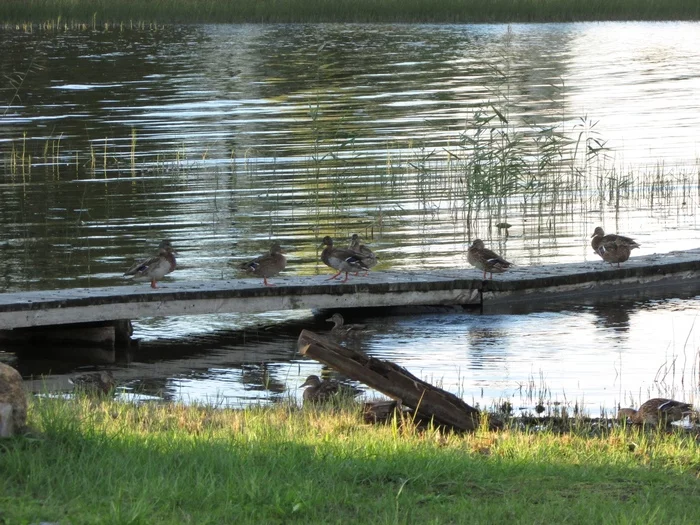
[0,23,700,290]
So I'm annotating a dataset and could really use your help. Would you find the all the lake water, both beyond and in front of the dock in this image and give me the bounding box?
[0,23,700,413]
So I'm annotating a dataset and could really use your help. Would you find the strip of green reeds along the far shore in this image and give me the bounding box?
[0,0,700,25]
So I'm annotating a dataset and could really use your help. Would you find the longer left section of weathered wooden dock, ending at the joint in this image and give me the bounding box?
[0,272,480,330]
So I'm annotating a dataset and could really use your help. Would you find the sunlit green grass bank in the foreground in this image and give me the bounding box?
[0,396,700,524]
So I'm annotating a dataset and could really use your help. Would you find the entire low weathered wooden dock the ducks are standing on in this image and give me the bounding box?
[0,249,700,336]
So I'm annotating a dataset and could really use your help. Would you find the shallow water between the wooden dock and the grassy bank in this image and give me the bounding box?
[5,286,700,415]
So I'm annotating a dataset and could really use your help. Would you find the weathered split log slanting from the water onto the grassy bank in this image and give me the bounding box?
[299,330,480,431]
